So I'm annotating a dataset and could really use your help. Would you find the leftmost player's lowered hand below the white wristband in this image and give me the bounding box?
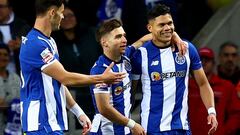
[78,114,92,135]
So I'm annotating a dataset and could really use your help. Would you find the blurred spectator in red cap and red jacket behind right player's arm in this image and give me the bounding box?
[189,47,240,135]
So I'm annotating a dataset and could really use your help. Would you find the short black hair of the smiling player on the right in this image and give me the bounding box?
[147,4,171,21]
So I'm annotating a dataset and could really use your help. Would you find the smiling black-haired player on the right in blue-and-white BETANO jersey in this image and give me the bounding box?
[132,5,218,135]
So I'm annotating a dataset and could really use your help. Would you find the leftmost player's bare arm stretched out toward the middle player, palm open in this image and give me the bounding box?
[43,61,125,86]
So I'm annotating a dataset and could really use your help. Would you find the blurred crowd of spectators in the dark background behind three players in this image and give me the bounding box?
[0,0,240,135]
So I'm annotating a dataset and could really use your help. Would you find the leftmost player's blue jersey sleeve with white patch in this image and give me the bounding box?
[23,40,56,70]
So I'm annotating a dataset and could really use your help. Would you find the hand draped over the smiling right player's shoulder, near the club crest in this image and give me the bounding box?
[172,32,187,56]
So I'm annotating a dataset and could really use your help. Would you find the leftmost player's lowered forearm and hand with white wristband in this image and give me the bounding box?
[64,86,92,135]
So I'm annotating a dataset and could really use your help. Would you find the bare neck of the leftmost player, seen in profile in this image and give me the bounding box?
[34,17,52,37]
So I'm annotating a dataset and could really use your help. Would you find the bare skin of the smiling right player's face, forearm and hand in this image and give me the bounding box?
[133,14,218,134]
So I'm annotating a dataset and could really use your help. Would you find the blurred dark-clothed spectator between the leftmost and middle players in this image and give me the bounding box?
[53,6,102,126]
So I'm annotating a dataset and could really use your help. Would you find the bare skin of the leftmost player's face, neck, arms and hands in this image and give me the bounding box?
[28,5,125,134]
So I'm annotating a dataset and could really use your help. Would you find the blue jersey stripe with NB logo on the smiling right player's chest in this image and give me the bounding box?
[146,44,164,132]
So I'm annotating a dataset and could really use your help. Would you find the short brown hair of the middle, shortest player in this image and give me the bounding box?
[96,19,122,43]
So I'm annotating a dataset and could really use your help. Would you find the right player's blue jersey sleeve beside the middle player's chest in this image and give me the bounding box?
[131,50,142,80]
